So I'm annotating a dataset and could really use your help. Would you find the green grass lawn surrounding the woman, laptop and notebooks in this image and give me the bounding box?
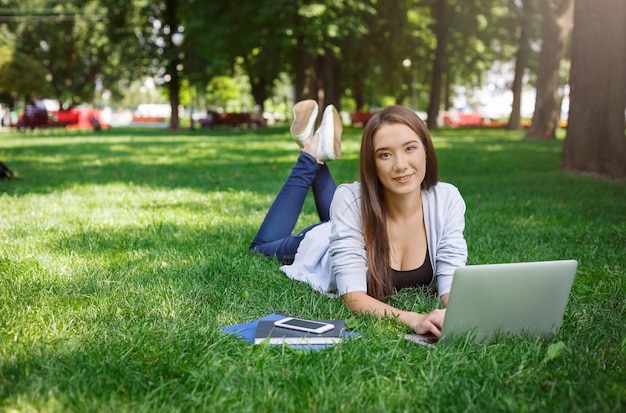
[0,128,626,412]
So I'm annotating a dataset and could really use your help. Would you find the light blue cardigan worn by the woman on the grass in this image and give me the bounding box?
[281,182,467,296]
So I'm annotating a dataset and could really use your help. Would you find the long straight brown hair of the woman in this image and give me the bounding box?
[359,106,439,300]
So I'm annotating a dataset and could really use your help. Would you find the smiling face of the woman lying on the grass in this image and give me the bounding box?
[373,123,426,195]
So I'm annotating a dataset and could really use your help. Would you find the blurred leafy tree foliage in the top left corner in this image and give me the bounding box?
[1,0,151,104]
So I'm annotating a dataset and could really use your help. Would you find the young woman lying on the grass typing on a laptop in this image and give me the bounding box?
[251,103,467,336]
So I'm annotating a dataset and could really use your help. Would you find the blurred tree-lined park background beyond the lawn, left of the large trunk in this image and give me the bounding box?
[0,0,616,140]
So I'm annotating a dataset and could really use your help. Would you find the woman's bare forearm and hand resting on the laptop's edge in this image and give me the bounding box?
[341,291,447,337]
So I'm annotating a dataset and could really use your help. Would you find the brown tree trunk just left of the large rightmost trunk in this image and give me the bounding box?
[525,0,574,139]
